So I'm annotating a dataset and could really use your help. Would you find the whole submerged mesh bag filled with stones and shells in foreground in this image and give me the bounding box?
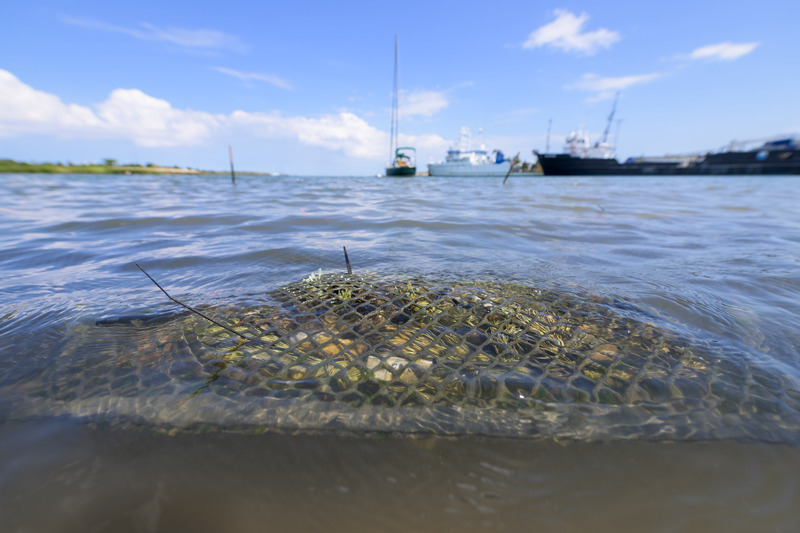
[12,275,800,442]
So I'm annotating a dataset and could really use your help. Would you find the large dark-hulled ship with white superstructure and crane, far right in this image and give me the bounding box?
[534,95,800,176]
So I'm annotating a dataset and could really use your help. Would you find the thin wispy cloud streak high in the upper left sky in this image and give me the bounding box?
[61,16,247,52]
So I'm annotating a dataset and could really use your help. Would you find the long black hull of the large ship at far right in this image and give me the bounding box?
[538,150,800,176]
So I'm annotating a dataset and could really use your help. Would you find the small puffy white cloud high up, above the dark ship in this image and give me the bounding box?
[522,9,621,55]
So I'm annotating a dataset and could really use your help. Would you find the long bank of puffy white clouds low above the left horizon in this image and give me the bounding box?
[0,69,446,160]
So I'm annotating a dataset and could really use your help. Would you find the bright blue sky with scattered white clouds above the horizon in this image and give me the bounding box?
[0,0,800,176]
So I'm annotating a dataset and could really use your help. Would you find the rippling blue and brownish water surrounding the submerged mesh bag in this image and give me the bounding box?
[0,175,800,532]
